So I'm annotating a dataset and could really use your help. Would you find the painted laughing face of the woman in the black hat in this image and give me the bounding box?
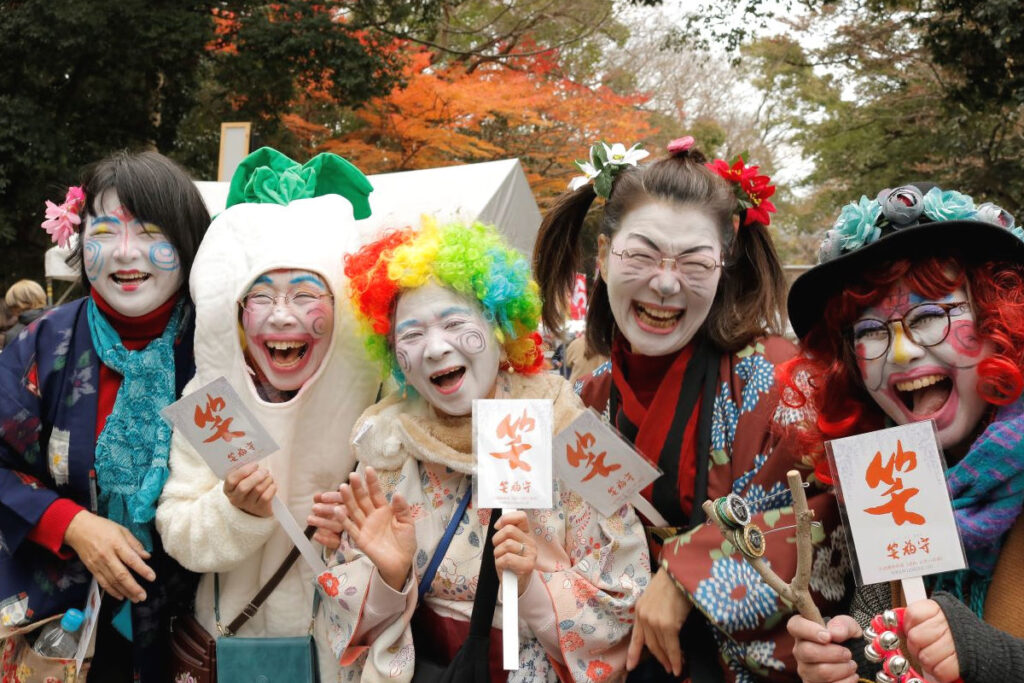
[853,282,992,449]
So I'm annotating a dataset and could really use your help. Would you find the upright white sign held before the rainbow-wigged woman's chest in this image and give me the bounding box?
[473,398,553,510]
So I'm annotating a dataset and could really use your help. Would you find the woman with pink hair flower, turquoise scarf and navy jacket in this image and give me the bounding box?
[0,152,210,682]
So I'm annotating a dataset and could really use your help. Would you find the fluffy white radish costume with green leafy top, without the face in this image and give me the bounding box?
[157,147,378,681]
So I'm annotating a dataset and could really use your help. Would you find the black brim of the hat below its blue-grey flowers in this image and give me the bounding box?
[786,183,1024,338]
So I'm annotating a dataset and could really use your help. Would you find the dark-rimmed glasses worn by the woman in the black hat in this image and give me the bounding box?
[850,301,971,360]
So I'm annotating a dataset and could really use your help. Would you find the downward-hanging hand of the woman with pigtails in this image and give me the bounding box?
[626,569,692,676]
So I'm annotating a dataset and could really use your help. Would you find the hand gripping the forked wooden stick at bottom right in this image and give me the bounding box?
[785,614,862,683]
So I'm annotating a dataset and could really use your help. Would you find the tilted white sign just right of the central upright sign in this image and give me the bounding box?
[554,410,662,517]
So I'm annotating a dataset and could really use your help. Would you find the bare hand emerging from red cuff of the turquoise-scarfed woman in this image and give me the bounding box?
[65,510,157,602]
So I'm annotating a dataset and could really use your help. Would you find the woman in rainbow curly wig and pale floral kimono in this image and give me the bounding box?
[307,222,649,683]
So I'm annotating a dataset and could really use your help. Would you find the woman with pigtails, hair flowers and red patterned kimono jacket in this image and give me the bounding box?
[535,137,847,682]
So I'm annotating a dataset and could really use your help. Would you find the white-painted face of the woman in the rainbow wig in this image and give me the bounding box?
[394,283,501,416]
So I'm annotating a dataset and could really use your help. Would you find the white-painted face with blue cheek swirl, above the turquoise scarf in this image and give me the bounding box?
[82,189,184,317]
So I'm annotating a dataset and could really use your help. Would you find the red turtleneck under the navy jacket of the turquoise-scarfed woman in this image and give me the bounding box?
[28,288,178,557]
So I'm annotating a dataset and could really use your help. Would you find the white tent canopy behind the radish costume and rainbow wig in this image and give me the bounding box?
[196,159,541,259]
